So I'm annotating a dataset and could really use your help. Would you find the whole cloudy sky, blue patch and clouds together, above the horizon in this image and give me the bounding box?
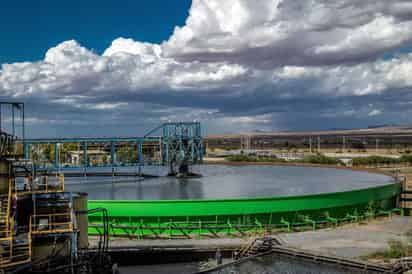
[0,0,412,137]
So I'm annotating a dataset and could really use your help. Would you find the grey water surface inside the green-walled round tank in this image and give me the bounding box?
[62,165,393,200]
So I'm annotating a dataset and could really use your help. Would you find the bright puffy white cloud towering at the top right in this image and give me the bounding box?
[163,0,412,68]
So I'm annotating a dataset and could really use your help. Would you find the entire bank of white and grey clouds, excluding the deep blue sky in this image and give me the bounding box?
[0,0,412,136]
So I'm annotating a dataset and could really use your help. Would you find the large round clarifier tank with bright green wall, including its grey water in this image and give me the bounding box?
[66,165,401,237]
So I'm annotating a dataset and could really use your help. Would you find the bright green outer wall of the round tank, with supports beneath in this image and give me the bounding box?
[88,183,401,236]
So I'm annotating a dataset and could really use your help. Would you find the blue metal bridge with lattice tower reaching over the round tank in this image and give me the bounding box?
[17,122,203,173]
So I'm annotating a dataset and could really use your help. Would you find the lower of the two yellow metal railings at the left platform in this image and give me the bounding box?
[29,212,74,234]
